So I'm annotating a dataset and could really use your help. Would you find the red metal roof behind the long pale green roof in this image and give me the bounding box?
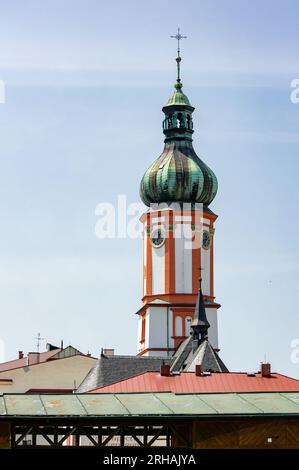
[89,372,299,393]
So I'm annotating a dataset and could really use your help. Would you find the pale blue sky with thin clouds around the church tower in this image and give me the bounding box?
[0,0,299,377]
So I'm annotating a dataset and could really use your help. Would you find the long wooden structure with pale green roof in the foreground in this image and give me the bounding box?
[0,392,299,449]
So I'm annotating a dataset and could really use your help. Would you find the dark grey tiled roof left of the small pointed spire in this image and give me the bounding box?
[77,355,171,393]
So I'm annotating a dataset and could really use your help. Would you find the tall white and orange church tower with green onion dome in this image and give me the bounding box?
[137,32,220,357]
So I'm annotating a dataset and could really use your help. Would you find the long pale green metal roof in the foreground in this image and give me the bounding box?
[0,392,299,419]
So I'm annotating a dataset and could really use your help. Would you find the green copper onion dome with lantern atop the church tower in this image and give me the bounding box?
[140,46,218,206]
